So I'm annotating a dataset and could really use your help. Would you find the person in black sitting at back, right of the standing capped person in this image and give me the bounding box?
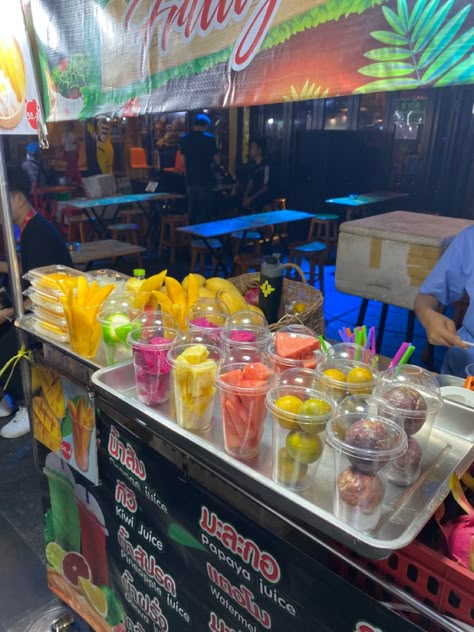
[242,138,272,213]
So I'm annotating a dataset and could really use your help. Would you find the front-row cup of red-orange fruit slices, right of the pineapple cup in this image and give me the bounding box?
[216,362,274,459]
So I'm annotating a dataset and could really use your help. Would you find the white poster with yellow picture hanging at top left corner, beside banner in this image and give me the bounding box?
[0,0,40,134]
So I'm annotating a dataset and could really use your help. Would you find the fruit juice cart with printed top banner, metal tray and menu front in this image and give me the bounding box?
[0,0,473,632]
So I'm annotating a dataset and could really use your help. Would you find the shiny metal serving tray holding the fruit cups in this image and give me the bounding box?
[92,362,474,559]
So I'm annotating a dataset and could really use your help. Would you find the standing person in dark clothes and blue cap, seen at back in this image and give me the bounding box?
[180,114,219,224]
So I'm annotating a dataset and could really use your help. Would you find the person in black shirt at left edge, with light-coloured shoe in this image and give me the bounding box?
[0,169,72,438]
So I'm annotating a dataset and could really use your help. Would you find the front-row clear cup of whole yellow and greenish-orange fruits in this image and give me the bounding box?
[266,384,336,491]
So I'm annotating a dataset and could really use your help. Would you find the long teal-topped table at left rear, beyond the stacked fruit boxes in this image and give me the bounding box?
[67,192,186,239]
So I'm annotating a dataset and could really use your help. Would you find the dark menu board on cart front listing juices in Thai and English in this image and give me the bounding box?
[39,413,419,632]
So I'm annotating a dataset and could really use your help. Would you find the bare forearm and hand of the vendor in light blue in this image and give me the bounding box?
[415,292,468,349]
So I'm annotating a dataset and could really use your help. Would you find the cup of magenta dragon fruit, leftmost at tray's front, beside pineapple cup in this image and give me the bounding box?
[127,327,178,406]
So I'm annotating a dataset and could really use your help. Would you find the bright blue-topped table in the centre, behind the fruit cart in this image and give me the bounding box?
[177,210,313,275]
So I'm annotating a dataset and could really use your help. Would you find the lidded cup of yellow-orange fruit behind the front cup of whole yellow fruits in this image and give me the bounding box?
[316,357,378,401]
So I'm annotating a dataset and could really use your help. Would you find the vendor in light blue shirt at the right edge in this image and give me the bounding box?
[415,226,474,378]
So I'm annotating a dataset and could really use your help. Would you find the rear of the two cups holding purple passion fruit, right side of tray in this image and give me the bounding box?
[374,364,443,485]
